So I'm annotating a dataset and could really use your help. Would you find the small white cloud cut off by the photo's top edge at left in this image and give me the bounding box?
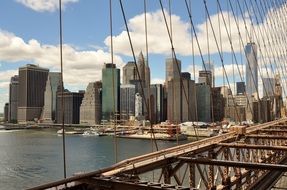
[16,0,79,12]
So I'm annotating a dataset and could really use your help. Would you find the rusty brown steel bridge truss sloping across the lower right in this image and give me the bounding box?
[29,118,287,189]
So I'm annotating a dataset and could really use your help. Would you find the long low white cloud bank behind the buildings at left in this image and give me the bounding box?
[0,30,123,108]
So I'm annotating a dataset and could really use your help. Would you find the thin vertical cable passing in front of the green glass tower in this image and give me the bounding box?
[109,0,118,163]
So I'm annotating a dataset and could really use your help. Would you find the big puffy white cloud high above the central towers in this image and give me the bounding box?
[105,10,191,55]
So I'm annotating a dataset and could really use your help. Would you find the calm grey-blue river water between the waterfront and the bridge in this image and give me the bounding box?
[0,129,190,190]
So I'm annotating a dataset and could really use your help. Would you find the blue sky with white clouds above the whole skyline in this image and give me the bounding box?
[0,0,285,112]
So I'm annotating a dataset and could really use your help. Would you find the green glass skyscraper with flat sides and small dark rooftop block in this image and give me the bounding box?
[102,63,120,121]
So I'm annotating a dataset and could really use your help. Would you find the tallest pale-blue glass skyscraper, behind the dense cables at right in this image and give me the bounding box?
[245,42,258,97]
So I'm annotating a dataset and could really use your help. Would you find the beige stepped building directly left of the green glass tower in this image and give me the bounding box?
[80,81,102,125]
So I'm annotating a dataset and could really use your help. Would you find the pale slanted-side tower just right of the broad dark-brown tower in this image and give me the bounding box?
[41,72,61,123]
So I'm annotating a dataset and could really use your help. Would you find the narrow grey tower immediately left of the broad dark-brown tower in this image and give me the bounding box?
[8,75,19,123]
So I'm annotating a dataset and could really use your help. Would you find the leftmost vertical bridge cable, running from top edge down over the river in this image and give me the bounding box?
[59,0,67,178]
